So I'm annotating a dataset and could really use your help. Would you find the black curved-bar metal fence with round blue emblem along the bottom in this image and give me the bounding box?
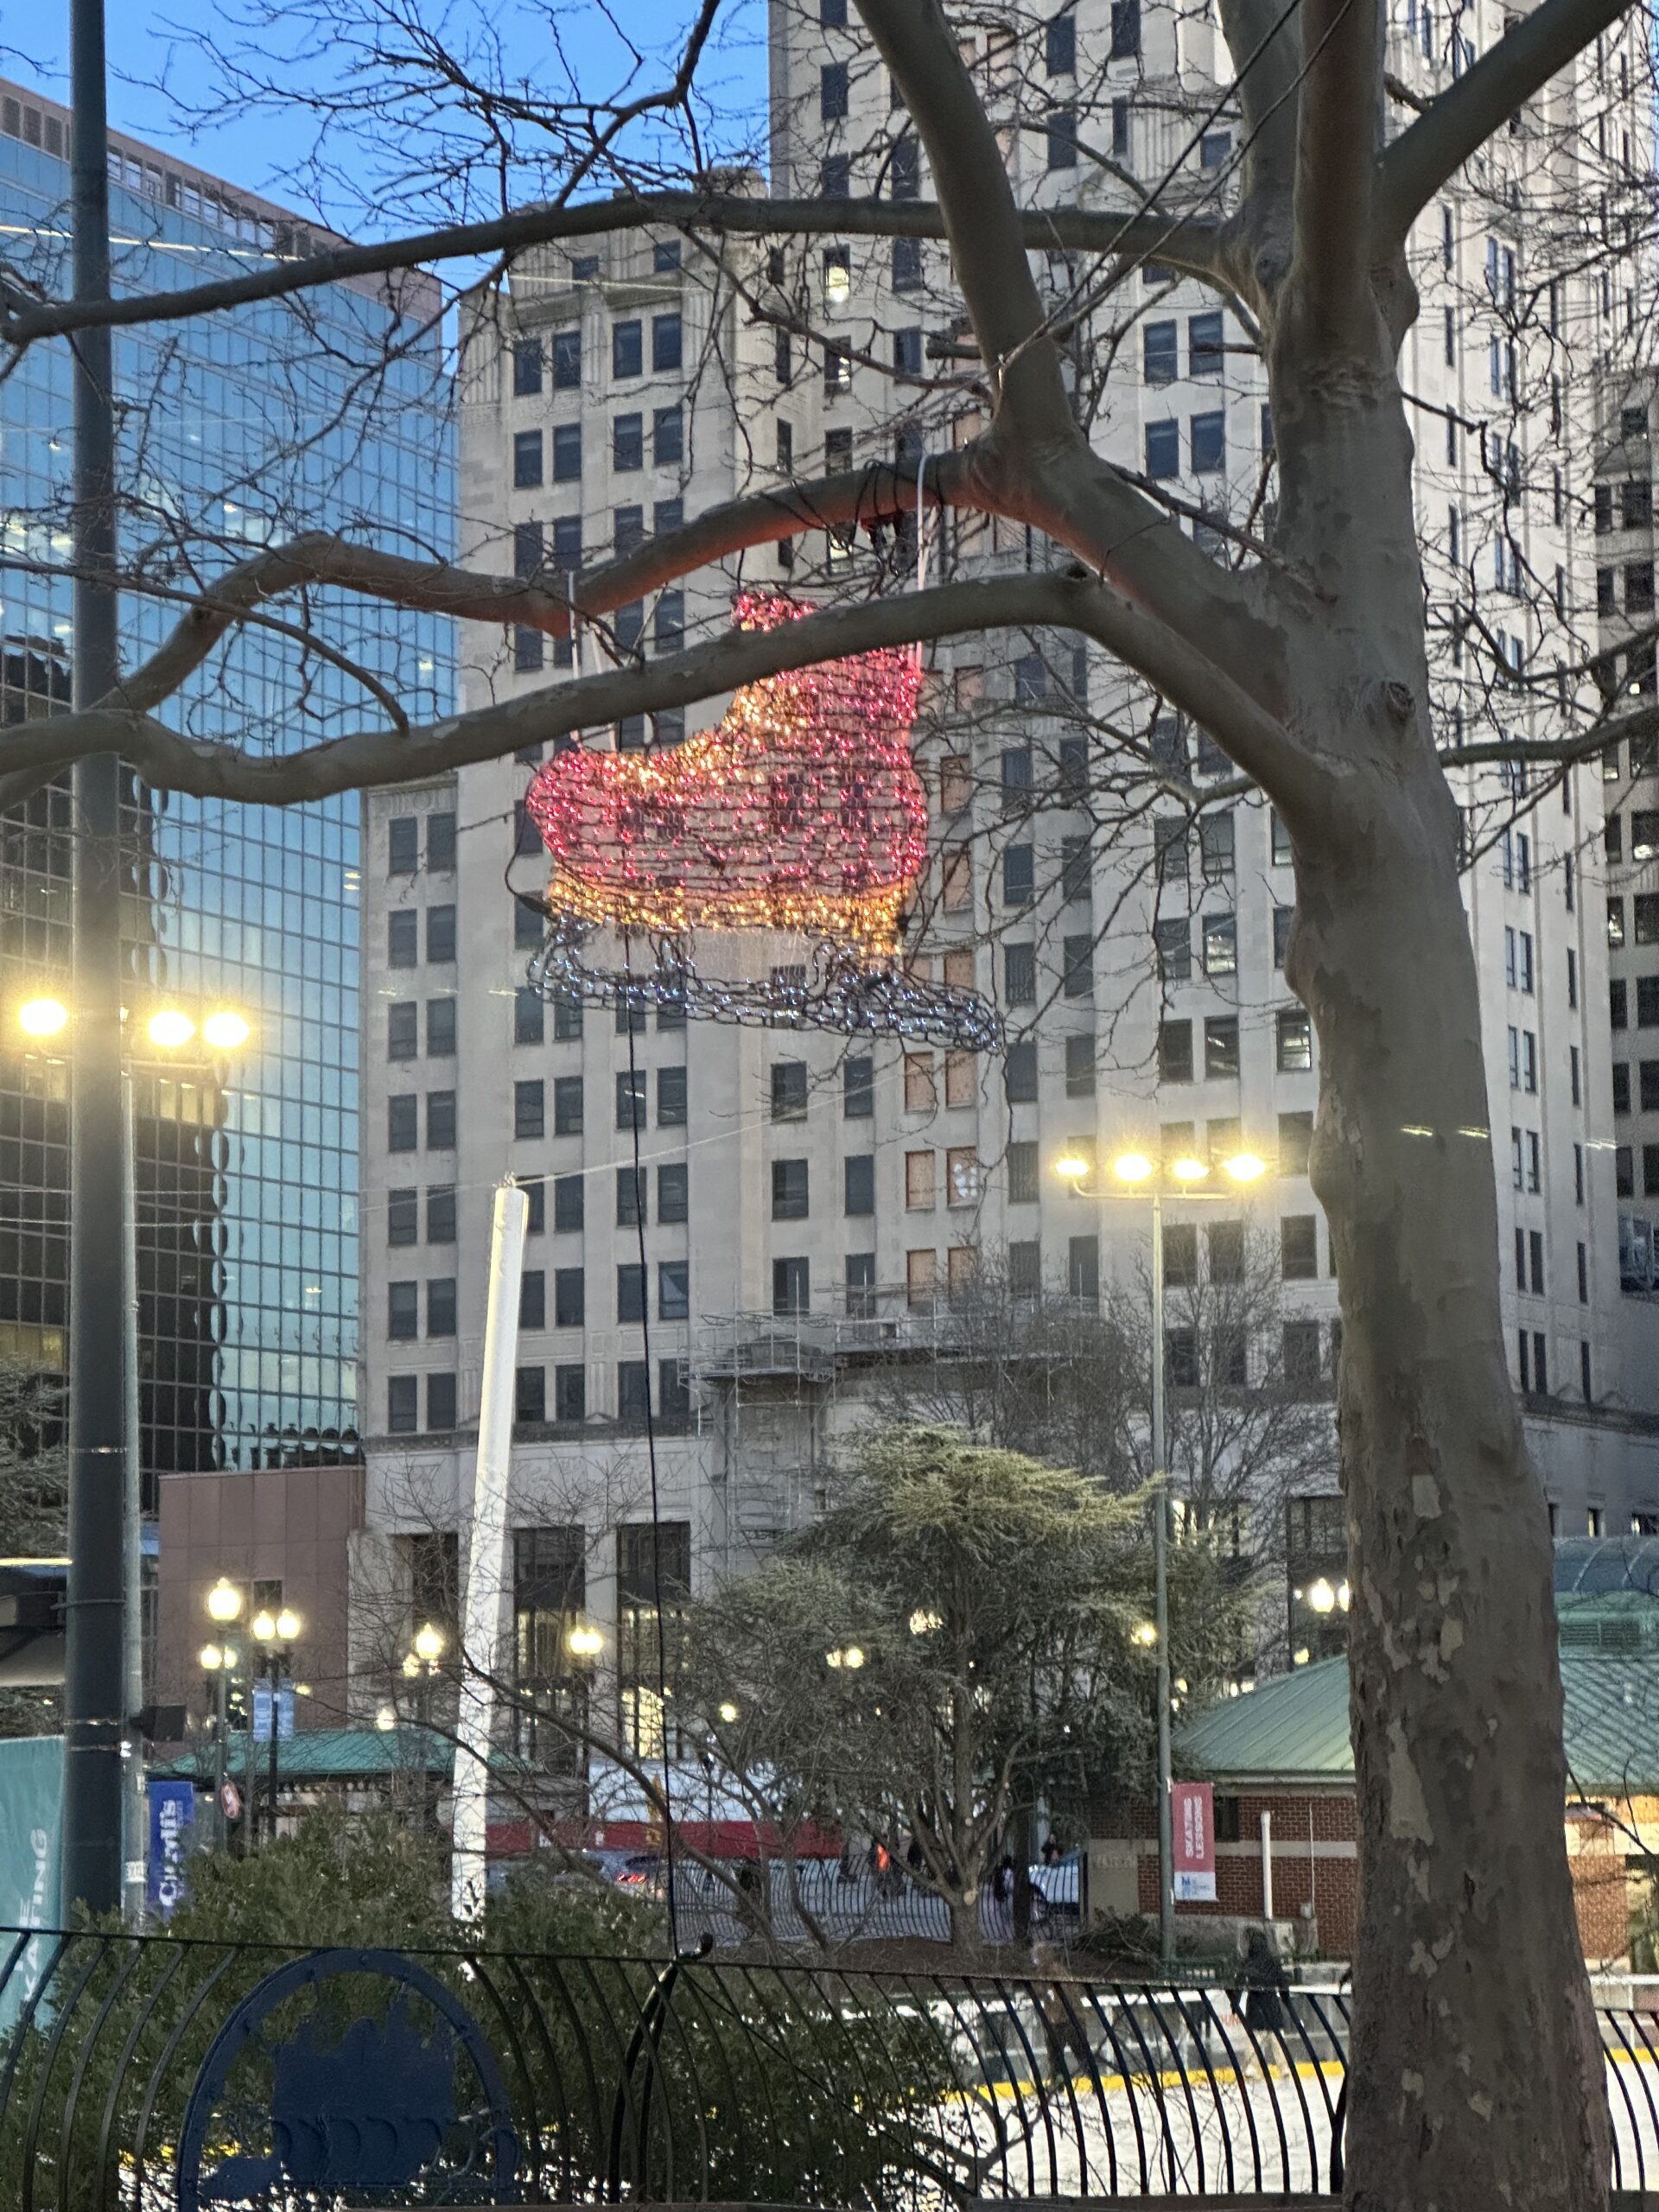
[0,1931,1659,2212]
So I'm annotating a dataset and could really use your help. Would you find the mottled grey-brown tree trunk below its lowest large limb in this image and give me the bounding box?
[1289,769,1608,2212]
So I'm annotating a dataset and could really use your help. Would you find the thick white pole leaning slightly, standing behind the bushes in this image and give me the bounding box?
[449,1177,531,1920]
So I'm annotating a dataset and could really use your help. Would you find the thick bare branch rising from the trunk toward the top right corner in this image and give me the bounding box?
[1374,0,1630,250]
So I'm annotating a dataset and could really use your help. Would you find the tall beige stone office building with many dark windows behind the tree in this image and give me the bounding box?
[363,0,1659,1778]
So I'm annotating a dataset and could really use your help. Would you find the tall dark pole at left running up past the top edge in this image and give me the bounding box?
[64,0,130,1913]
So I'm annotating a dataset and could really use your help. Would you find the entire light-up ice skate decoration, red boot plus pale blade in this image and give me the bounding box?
[524,593,1000,1051]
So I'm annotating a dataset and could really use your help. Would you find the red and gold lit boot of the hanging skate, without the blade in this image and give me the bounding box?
[526,593,927,956]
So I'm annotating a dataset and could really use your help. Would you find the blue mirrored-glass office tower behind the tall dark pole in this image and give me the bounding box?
[0,84,454,1697]
